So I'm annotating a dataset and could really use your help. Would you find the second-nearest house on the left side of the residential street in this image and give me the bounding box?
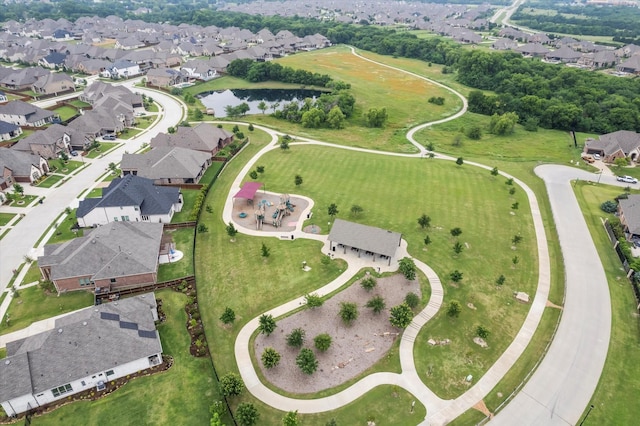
[11,124,79,159]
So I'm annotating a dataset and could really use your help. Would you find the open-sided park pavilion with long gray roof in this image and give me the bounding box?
[329,219,402,265]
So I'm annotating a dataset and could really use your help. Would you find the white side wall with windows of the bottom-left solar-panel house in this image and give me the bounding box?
[2,353,162,416]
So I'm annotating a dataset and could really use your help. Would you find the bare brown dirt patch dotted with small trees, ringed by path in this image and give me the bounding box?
[254,274,421,394]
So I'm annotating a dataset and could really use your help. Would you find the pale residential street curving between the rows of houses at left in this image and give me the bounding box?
[0,86,184,293]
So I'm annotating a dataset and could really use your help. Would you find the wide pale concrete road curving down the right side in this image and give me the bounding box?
[491,165,612,425]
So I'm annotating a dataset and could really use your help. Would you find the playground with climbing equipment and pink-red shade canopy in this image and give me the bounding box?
[233,191,309,232]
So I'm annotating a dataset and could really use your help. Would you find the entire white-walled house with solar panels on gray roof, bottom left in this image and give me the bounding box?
[0,293,162,416]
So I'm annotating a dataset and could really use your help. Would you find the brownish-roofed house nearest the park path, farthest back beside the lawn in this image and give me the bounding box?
[150,123,233,157]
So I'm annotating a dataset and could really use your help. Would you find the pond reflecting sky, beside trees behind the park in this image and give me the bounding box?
[198,89,323,118]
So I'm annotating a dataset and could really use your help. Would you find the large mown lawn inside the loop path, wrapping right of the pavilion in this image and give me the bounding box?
[255,146,537,398]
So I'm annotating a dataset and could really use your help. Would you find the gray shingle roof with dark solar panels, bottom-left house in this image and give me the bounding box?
[0,293,162,401]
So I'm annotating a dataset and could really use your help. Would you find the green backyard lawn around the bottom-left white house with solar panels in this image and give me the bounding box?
[33,290,218,426]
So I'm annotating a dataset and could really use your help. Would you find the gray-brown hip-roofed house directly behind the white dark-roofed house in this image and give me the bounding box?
[120,146,211,185]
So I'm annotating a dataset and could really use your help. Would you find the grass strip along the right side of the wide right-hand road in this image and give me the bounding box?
[575,182,640,425]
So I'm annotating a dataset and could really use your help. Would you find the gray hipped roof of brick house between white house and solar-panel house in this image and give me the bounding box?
[38,222,163,280]
